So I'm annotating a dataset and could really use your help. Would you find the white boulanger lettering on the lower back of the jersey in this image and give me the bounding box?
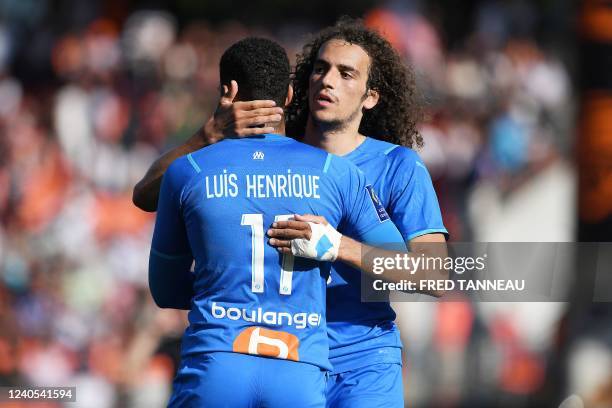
[211,302,322,330]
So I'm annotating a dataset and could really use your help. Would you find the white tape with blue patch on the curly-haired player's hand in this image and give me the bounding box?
[291,222,342,262]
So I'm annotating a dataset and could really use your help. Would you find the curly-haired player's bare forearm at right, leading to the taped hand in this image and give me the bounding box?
[336,236,448,297]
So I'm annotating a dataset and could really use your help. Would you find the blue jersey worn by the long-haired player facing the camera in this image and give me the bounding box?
[327,138,447,372]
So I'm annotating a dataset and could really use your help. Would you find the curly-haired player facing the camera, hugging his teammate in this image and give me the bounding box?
[284,19,447,407]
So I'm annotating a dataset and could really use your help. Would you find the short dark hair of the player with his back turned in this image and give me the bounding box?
[219,37,291,106]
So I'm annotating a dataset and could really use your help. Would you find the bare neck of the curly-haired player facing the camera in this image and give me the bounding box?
[304,118,365,156]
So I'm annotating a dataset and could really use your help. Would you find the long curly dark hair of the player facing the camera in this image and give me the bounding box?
[286,17,423,147]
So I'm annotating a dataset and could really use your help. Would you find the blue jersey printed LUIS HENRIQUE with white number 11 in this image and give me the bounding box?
[152,135,391,369]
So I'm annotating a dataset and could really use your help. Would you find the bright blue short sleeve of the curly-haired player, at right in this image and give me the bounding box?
[387,147,448,242]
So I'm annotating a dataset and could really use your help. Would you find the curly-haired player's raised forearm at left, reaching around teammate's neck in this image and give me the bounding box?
[132,124,216,212]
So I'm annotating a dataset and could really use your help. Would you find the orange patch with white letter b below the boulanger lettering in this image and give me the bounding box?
[233,327,300,361]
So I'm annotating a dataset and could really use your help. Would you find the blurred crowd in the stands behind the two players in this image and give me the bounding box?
[0,1,592,407]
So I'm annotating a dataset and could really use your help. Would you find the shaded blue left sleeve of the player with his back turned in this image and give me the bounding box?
[149,159,194,309]
